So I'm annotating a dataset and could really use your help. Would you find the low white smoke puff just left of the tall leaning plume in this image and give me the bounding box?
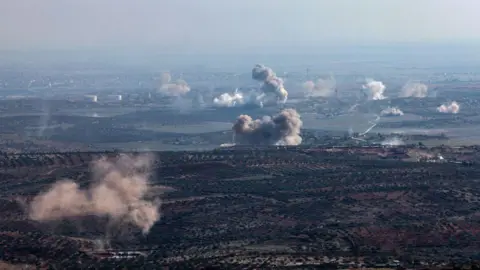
[213,89,265,107]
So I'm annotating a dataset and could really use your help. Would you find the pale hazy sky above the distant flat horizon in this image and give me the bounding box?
[0,0,480,52]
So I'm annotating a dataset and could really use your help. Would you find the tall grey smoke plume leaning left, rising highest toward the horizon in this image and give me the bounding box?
[252,64,288,103]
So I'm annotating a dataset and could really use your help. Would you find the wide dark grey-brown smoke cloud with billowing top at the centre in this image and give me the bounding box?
[232,109,303,145]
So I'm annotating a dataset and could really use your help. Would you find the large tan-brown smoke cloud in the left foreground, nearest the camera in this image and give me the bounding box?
[29,155,160,233]
